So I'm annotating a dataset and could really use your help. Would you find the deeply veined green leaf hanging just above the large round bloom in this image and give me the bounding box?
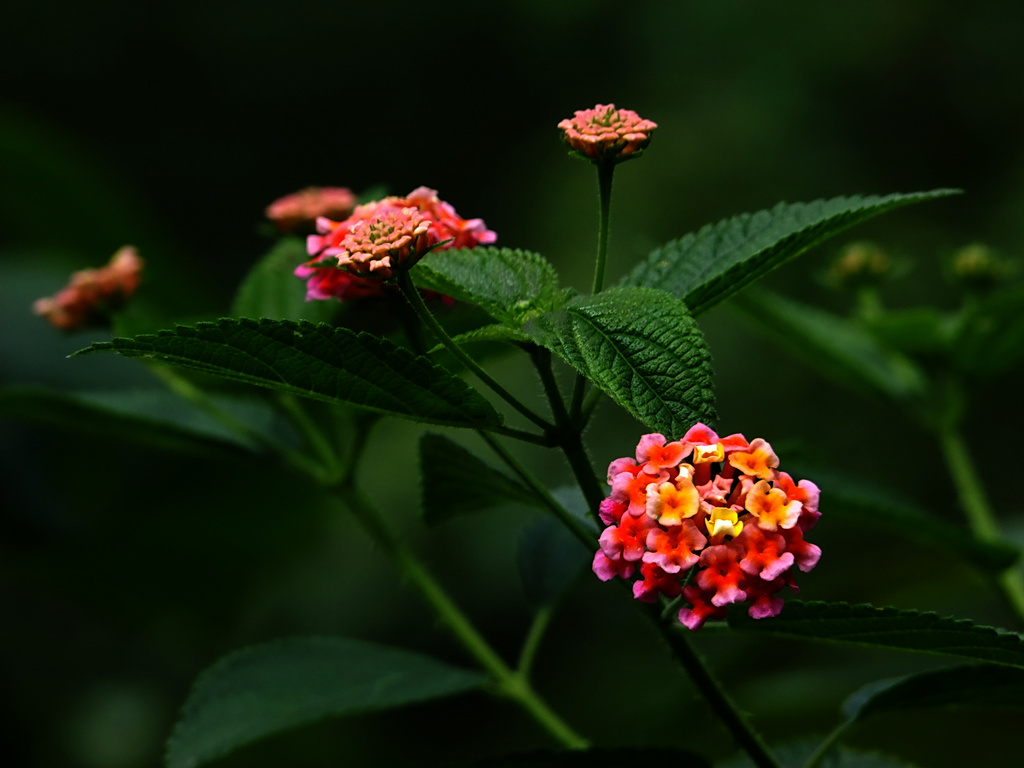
[523,288,715,437]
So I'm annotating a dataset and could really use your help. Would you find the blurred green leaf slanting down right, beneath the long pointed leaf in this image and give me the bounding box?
[733,288,928,400]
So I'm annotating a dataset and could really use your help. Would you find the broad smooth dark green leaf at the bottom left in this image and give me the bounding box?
[166,637,487,768]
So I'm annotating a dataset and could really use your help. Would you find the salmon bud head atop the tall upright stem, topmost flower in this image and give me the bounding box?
[558,104,657,163]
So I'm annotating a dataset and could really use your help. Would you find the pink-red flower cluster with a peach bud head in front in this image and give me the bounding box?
[295,186,498,301]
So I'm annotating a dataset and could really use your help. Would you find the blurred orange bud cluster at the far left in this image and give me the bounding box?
[32,246,142,331]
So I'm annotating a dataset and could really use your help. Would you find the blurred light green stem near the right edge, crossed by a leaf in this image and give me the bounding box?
[938,425,1024,622]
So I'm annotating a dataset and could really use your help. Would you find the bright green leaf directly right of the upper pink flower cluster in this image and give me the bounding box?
[411,248,567,328]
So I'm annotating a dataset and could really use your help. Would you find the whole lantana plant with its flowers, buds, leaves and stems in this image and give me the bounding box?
[16,104,1024,768]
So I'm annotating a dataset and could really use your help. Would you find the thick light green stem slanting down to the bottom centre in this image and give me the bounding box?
[338,482,589,750]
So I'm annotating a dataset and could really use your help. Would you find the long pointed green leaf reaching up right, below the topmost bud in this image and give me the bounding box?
[622,189,958,314]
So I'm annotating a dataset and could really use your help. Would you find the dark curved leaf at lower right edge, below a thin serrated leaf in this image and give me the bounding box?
[843,665,1024,724]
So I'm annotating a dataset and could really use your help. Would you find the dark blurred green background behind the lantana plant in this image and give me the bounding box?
[0,0,1024,768]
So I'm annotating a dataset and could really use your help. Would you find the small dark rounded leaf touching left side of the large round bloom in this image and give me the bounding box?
[516,516,594,607]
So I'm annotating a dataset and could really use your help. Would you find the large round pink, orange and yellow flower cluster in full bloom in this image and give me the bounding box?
[594,424,821,630]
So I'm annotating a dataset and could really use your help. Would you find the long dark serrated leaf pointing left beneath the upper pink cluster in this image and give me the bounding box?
[75,318,501,427]
